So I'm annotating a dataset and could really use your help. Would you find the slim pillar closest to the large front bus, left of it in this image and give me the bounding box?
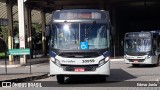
[41,10,46,56]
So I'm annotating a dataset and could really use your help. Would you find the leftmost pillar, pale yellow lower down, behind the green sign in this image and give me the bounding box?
[6,0,13,62]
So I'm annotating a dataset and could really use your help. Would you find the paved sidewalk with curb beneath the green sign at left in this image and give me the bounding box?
[0,58,49,82]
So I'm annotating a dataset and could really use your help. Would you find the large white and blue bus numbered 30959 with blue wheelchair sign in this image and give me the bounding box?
[50,9,111,83]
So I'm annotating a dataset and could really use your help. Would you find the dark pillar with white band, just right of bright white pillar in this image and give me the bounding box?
[26,5,33,58]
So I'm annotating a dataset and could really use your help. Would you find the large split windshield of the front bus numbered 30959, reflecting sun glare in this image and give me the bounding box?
[51,23,109,50]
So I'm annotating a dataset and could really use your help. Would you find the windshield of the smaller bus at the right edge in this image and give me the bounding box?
[124,38,151,53]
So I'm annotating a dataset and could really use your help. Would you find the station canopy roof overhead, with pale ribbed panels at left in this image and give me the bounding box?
[0,0,158,24]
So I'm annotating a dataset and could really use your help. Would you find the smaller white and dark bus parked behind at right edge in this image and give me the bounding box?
[124,31,160,66]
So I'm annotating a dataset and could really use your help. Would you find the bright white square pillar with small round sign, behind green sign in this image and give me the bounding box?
[18,0,26,64]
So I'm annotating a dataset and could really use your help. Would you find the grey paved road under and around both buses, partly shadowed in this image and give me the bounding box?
[2,61,160,90]
